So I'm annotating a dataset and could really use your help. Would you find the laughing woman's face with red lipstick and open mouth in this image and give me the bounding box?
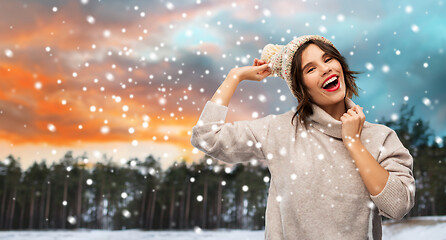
[301,44,346,106]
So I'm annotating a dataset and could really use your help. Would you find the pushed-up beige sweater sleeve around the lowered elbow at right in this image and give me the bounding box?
[370,130,415,220]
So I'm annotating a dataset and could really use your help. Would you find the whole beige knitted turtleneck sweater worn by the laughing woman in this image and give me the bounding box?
[191,98,415,240]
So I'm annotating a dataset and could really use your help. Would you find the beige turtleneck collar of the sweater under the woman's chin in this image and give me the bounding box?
[308,98,356,139]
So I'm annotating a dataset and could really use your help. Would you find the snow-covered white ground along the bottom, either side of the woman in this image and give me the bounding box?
[0,216,446,240]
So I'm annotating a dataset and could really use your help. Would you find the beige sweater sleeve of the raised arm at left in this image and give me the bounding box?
[191,101,272,163]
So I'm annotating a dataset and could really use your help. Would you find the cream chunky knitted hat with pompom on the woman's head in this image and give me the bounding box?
[260,35,335,98]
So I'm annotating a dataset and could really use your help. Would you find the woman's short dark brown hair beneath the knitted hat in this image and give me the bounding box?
[291,40,359,131]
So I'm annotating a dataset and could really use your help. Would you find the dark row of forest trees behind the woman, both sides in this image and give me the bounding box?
[0,105,446,230]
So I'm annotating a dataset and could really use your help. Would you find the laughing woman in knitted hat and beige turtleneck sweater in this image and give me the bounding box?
[191,35,415,239]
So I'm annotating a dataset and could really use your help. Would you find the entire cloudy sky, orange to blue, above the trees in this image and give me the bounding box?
[0,0,446,168]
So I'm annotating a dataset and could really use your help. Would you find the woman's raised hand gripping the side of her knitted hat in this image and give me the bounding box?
[229,58,271,82]
